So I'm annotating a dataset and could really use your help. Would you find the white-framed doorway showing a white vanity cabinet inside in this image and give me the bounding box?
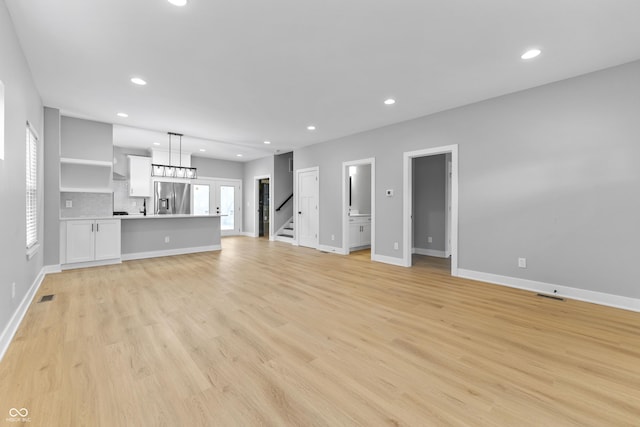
[342,158,376,259]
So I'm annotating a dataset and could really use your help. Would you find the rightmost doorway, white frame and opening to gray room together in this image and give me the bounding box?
[403,145,458,276]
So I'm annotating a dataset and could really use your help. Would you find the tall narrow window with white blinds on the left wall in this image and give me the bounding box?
[26,122,38,258]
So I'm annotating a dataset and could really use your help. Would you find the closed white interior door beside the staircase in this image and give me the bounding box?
[296,169,319,248]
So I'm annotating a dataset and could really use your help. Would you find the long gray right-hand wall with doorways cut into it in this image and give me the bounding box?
[294,61,640,298]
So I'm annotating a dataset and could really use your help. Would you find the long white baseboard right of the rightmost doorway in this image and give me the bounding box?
[458,268,640,312]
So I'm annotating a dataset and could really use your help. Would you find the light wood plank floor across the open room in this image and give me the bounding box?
[0,237,640,427]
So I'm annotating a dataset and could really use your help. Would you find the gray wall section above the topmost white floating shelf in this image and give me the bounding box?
[60,116,113,162]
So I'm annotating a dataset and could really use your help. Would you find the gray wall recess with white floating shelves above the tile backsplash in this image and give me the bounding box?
[60,116,113,193]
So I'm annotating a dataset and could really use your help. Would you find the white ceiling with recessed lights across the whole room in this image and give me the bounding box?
[5,0,640,161]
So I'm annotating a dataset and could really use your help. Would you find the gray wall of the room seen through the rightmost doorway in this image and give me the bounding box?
[413,154,447,251]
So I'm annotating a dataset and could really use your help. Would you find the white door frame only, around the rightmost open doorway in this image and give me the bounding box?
[402,144,458,276]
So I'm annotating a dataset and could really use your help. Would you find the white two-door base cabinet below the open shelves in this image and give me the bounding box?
[66,219,121,264]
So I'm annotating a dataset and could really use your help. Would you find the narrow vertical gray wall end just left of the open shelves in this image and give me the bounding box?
[43,107,60,265]
